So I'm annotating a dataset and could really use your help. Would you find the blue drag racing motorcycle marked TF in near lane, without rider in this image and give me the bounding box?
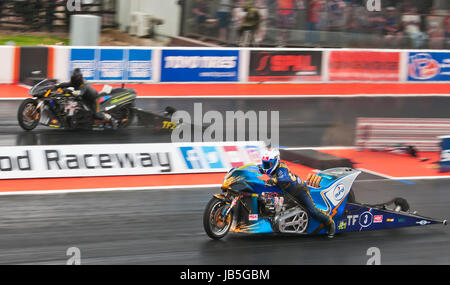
[203,165,447,239]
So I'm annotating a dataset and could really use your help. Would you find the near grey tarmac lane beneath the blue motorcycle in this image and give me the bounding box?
[0,178,450,265]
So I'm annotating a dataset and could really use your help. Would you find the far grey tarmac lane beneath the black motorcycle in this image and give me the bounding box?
[0,95,450,147]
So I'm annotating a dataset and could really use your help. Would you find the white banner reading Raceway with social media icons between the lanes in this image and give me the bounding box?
[0,142,264,179]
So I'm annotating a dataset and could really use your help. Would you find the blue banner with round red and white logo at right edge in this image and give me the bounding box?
[408,52,450,81]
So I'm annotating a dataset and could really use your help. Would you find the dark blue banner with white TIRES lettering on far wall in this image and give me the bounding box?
[161,50,239,82]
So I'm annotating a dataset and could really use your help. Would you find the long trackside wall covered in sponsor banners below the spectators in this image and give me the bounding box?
[0,46,450,84]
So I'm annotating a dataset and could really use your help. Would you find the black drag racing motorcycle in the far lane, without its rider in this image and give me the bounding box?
[17,79,136,131]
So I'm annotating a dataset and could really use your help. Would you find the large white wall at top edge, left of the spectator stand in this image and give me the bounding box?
[117,0,181,36]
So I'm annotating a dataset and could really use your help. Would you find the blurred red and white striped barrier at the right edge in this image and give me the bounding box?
[355,118,450,151]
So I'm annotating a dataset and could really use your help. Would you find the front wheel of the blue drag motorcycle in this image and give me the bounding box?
[203,197,232,240]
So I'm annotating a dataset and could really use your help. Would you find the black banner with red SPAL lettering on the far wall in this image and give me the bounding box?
[249,50,322,82]
